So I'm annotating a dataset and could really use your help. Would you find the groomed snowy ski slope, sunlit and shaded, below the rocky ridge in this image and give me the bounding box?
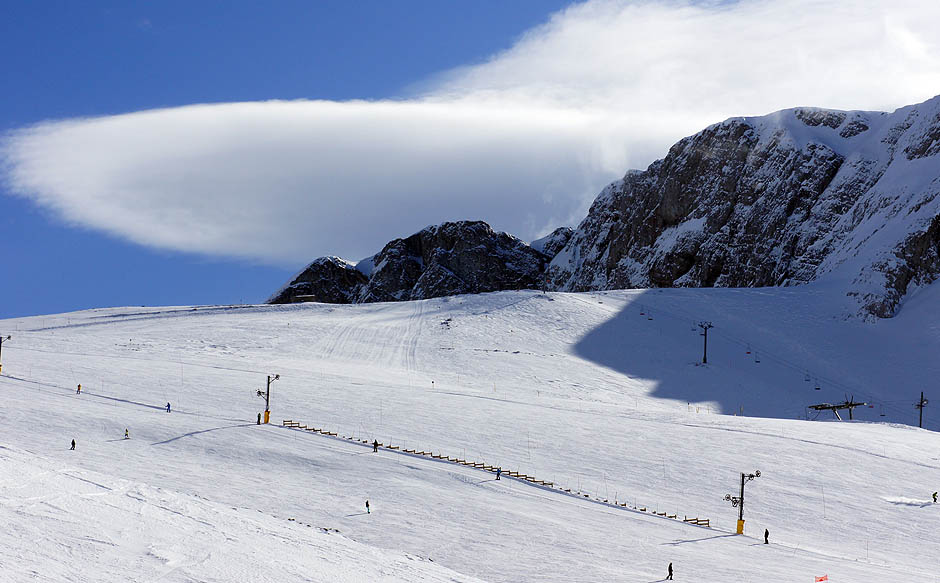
[0,285,940,582]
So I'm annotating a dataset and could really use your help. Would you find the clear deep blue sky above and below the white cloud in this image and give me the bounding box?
[0,0,565,317]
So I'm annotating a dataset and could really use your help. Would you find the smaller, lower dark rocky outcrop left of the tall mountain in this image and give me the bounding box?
[269,221,551,303]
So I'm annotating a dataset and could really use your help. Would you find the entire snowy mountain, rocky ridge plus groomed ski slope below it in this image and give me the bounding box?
[7,99,940,583]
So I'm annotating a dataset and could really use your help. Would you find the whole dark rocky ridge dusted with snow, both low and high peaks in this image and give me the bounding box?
[271,97,940,317]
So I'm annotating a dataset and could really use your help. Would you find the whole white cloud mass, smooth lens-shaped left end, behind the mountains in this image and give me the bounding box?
[3,0,940,266]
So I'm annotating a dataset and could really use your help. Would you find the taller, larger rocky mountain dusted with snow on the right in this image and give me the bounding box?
[549,98,940,317]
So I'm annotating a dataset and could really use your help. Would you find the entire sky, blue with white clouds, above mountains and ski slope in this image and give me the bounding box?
[0,0,940,320]
